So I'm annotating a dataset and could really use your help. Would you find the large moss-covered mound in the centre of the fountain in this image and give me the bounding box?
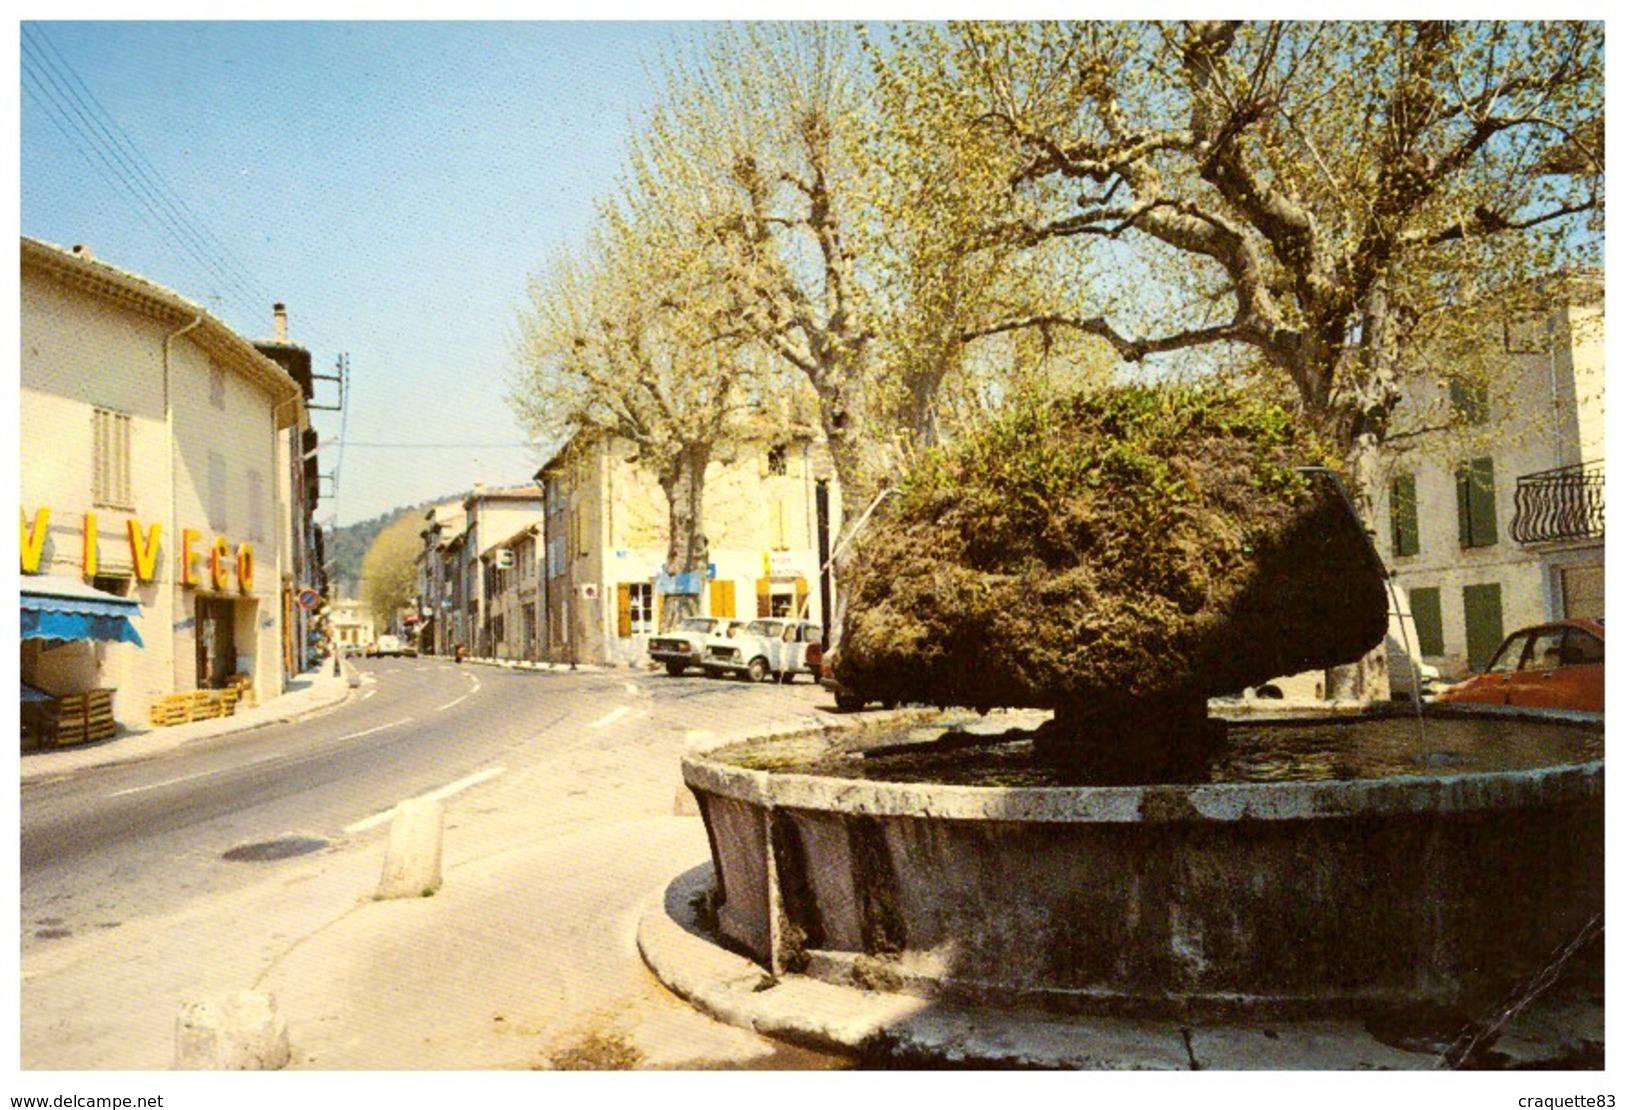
[835,387,1388,773]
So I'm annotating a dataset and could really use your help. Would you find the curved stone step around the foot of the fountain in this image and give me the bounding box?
[637,863,1602,1071]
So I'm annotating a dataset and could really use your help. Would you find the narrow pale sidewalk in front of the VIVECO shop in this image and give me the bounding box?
[21,660,359,783]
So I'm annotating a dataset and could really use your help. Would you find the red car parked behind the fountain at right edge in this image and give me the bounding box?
[1437,621,1602,713]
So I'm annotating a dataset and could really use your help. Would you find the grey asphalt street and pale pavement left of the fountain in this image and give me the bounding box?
[21,658,858,1068]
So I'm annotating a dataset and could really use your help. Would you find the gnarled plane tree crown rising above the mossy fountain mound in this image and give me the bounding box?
[882,21,1604,487]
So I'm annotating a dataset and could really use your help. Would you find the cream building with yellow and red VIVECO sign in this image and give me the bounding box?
[20,239,307,734]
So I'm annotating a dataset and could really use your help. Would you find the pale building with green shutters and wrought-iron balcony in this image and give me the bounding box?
[1376,271,1606,678]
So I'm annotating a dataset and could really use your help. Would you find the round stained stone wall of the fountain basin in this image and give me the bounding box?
[683,717,1604,1019]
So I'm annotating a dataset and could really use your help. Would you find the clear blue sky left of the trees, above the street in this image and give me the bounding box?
[20,21,702,523]
